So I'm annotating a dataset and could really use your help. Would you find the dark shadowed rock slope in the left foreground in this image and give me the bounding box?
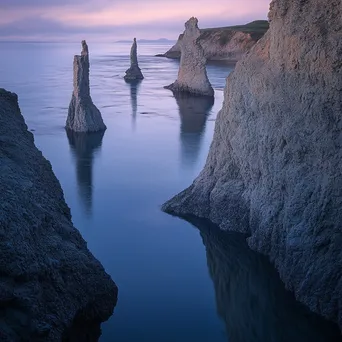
[0,89,117,342]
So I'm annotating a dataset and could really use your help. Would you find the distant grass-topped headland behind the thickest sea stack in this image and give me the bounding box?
[157,20,269,62]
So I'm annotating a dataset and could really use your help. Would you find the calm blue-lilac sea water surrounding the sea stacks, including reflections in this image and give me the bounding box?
[0,43,340,342]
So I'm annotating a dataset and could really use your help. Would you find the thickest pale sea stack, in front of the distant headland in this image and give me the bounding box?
[165,17,214,96]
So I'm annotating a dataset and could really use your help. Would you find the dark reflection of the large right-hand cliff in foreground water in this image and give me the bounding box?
[191,219,341,342]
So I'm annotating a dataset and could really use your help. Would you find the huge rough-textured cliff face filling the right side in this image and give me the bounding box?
[163,0,342,328]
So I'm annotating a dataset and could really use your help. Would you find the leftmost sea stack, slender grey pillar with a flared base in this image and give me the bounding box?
[65,40,107,132]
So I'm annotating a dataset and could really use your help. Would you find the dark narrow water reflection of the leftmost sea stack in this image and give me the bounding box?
[66,130,104,216]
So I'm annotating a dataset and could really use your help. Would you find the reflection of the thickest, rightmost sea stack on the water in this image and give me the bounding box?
[174,93,214,166]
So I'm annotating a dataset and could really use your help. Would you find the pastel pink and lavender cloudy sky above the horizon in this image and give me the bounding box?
[0,0,270,42]
